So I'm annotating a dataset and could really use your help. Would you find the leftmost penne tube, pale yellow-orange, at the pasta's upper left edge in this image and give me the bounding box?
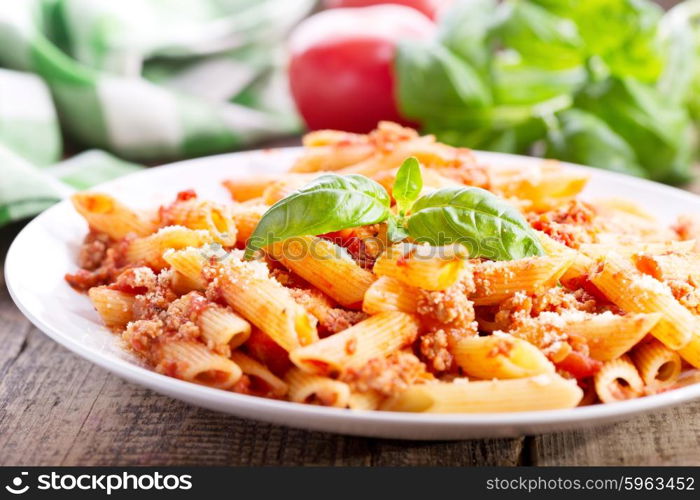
[71,192,155,240]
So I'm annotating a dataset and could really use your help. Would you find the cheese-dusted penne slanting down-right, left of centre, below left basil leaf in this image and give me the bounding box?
[218,257,318,351]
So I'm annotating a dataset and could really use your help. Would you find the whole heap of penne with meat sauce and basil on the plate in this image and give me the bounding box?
[66,122,700,413]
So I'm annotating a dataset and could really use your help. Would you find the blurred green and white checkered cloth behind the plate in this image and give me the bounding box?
[0,0,316,225]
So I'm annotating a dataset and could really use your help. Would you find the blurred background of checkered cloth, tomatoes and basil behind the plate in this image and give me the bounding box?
[0,0,700,226]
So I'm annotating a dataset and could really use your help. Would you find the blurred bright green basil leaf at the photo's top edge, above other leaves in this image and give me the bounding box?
[500,0,589,69]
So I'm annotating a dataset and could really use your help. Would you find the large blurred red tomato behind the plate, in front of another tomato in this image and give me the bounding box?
[289,5,435,133]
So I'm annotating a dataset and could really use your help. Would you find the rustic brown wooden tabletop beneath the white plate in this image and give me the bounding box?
[0,215,700,466]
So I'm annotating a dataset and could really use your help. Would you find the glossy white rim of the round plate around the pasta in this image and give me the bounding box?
[4,147,700,435]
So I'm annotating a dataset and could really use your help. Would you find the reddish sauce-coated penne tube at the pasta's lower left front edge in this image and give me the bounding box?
[157,340,242,389]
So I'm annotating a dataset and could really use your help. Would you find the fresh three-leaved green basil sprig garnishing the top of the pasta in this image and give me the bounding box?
[245,157,544,260]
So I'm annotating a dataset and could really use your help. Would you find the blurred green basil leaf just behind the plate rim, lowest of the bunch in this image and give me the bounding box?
[545,109,646,177]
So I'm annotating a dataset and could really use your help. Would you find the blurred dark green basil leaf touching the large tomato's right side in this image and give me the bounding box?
[394,40,491,122]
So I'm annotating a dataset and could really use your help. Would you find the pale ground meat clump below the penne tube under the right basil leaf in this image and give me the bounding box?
[417,281,476,331]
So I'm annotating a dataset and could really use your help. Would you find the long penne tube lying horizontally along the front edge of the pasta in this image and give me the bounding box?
[380,373,583,413]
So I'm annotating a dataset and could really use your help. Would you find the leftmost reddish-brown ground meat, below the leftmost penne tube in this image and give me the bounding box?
[65,231,131,292]
